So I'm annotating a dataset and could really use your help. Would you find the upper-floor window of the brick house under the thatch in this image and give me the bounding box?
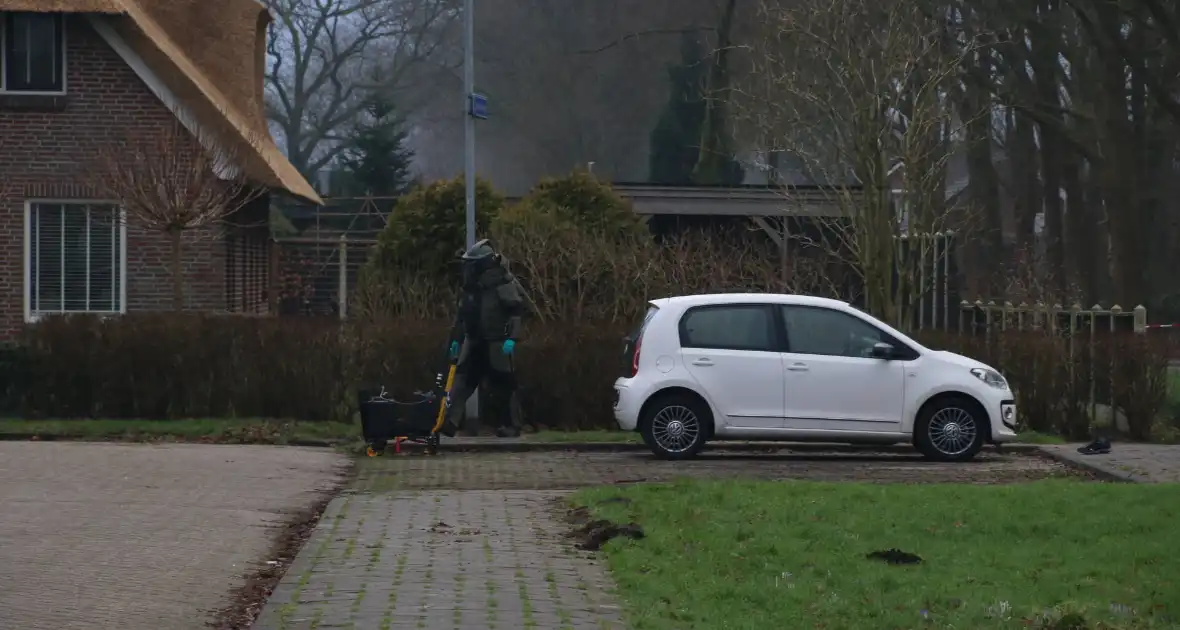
[0,12,66,94]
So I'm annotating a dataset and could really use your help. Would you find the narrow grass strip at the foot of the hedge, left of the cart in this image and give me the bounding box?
[0,419,360,444]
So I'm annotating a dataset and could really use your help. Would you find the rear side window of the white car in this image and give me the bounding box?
[680,304,775,352]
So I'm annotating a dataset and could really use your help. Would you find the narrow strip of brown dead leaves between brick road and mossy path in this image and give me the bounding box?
[207,467,355,630]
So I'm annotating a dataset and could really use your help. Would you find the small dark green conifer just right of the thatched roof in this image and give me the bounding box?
[340,94,414,197]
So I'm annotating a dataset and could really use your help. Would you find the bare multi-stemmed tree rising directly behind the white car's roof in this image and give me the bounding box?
[734,0,985,326]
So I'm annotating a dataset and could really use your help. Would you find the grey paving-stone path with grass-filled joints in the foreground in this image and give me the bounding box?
[254,491,623,630]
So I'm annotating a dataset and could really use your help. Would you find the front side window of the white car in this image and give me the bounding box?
[782,307,896,357]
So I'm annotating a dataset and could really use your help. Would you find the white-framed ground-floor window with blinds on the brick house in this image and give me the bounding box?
[27,202,125,319]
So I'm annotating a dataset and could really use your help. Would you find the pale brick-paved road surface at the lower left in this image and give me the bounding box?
[0,442,346,630]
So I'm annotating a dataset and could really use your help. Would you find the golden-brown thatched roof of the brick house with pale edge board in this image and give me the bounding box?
[0,0,322,203]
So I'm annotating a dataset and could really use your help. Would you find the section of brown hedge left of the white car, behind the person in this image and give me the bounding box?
[0,314,623,428]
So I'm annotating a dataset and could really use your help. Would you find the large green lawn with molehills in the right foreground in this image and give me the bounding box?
[572,480,1180,630]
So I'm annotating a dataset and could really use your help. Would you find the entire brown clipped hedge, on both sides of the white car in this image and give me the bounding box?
[0,314,1168,439]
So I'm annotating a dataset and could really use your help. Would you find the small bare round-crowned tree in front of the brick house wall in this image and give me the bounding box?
[89,120,264,310]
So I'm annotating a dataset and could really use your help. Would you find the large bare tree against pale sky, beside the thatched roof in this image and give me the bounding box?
[266,0,459,176]
